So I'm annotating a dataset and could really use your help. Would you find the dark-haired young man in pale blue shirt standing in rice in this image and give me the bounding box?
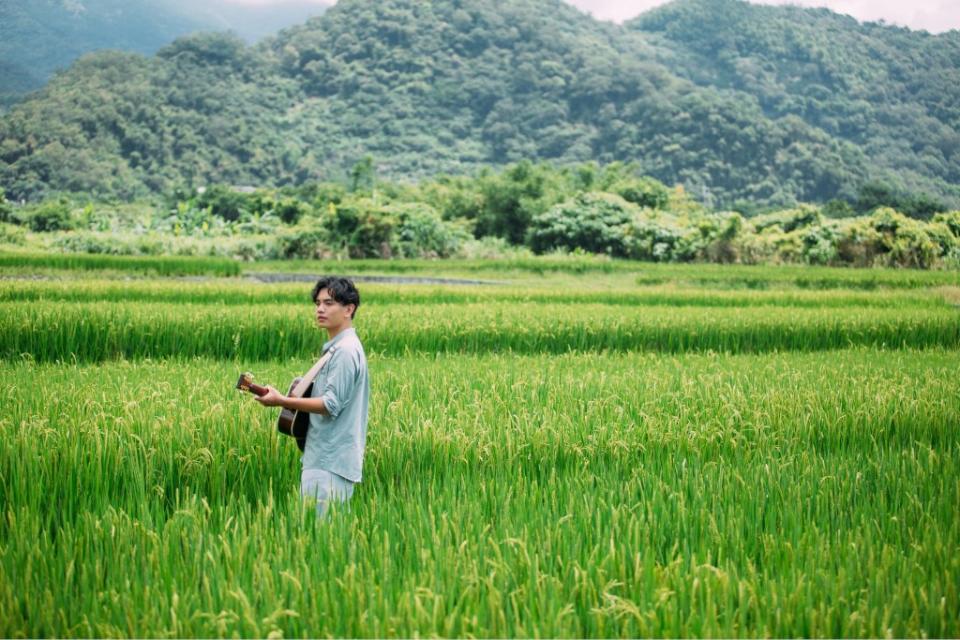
[257,278,370,516]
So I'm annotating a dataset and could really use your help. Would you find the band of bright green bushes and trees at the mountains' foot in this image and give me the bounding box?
[0,158,960,269]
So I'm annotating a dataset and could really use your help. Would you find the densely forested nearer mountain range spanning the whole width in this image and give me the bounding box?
[0,0,960,207]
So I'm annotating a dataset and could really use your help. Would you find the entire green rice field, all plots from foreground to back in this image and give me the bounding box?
[0,263,960,638]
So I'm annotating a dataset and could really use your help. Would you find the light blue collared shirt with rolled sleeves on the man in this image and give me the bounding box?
[302,327,370,482]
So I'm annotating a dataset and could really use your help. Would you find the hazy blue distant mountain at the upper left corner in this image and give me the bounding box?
[0,0,324,107]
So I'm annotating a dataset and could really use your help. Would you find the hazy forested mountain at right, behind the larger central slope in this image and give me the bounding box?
[627,0,960,210]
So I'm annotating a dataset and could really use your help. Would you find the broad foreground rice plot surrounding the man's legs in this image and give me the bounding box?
[0,349,960,637]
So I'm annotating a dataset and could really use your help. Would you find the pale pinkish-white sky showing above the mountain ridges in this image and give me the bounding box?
[223,0,960,33]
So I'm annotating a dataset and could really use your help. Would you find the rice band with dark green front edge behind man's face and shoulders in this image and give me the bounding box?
[0,301,960,361]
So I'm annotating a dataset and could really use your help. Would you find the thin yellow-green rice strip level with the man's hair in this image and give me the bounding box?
[0,279,946,308]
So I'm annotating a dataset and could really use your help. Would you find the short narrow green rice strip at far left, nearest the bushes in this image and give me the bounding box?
[0,252,240,276]
